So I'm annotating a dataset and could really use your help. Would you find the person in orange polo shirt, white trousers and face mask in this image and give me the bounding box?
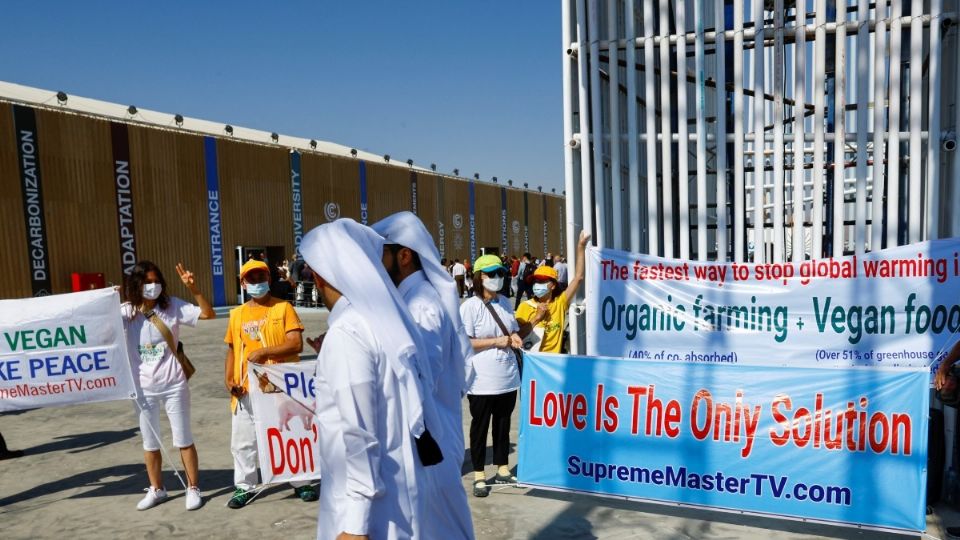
[224,259,318,509]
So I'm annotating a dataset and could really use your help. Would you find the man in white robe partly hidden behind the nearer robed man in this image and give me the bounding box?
[372,212,474,539]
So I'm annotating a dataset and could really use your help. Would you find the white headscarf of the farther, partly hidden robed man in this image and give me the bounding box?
[372,212,473,368]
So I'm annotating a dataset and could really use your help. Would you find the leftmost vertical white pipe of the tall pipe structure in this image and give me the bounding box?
[560,0,584,354]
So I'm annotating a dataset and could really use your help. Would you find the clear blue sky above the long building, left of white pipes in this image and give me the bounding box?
[0,0,563,193]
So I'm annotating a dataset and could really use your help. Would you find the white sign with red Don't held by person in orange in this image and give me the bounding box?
[247,360,320,484]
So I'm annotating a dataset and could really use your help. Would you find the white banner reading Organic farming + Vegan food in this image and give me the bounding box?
[587,239,960,367]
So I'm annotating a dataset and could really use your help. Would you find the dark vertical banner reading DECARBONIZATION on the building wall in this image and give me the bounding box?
[13,105,51,296]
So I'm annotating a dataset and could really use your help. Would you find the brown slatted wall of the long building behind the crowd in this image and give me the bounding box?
[0,103,563,303]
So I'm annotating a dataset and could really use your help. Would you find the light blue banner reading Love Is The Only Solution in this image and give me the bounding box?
[517,354,929,531]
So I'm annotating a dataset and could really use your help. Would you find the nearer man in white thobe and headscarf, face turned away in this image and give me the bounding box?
[300,219,443,540]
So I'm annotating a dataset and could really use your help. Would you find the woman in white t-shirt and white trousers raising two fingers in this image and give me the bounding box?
[120,261,216,510]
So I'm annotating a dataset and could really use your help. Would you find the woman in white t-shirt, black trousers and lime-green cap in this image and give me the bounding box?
[460,255,523,497]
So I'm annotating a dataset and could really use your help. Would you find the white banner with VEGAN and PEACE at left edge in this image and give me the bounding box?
[0,289,136,412]
